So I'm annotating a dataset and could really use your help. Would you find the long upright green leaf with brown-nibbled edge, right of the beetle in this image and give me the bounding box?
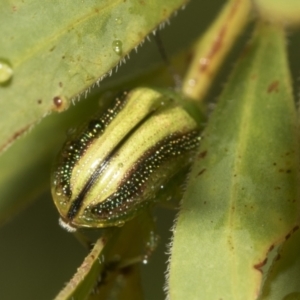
[169,24,299,300]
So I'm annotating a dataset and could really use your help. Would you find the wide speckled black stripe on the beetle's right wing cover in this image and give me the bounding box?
[91,130,200,220]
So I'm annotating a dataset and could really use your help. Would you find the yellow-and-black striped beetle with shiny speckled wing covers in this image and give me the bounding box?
[51,87,200,232]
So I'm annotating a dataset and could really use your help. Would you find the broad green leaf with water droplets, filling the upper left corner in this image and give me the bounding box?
[0,0,185,152]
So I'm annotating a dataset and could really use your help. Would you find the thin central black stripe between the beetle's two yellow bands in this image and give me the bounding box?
[67,109,156,220]
